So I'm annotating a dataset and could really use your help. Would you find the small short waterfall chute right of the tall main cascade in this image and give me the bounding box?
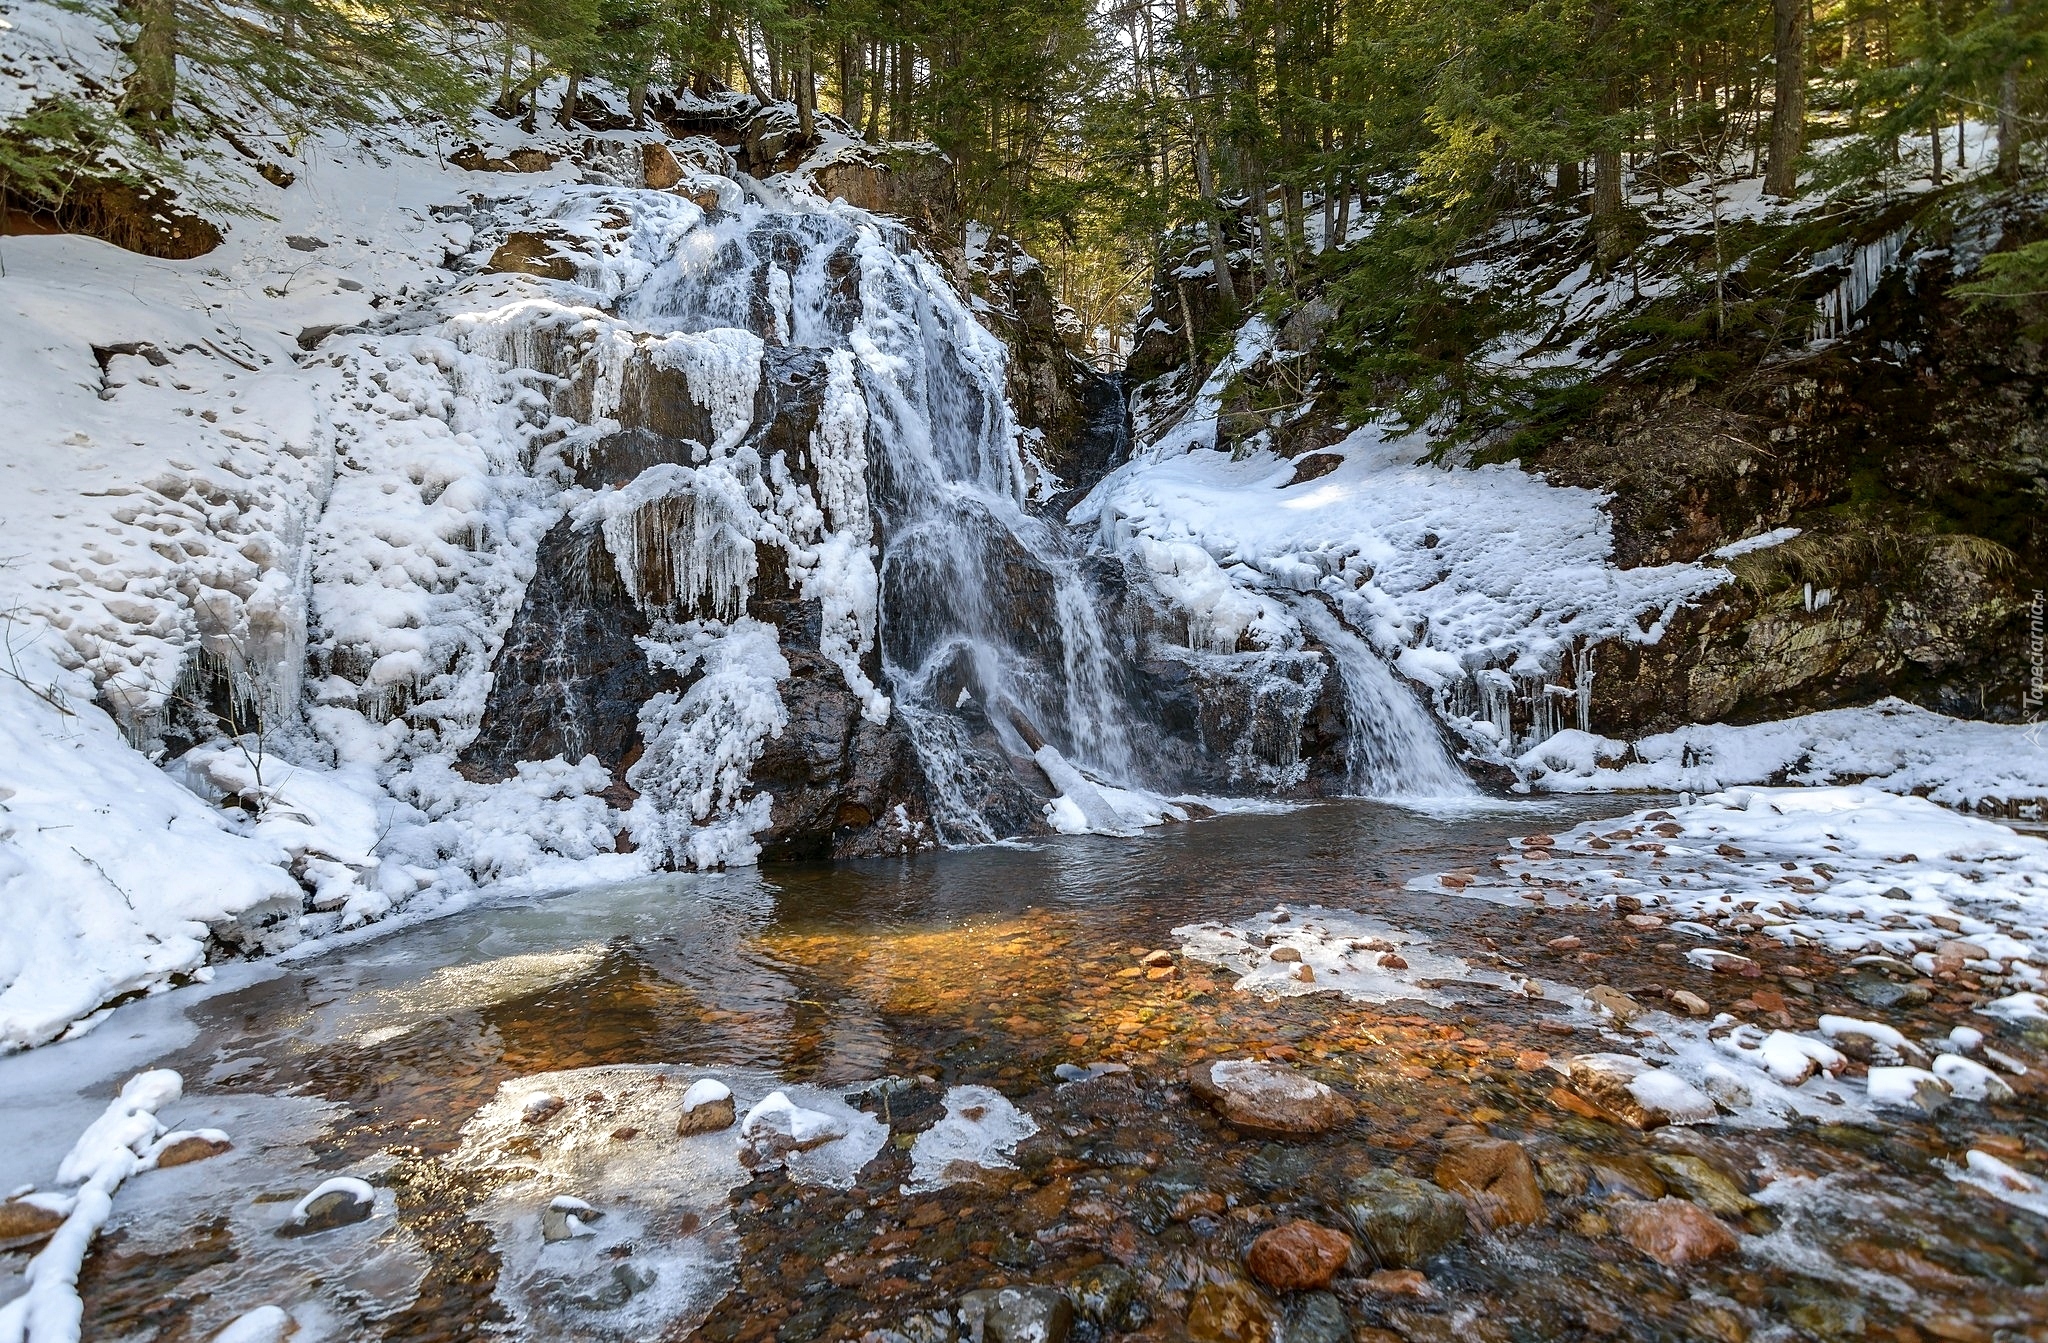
[1294,598,1475,798]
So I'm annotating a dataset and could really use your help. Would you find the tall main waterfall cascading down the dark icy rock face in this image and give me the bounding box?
[625,203,1141,841]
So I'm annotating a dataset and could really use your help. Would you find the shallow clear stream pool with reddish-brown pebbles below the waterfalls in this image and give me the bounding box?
[0,796,2048,1343]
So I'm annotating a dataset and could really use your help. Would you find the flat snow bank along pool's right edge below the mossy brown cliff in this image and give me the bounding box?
[1516,700,2048,807]
